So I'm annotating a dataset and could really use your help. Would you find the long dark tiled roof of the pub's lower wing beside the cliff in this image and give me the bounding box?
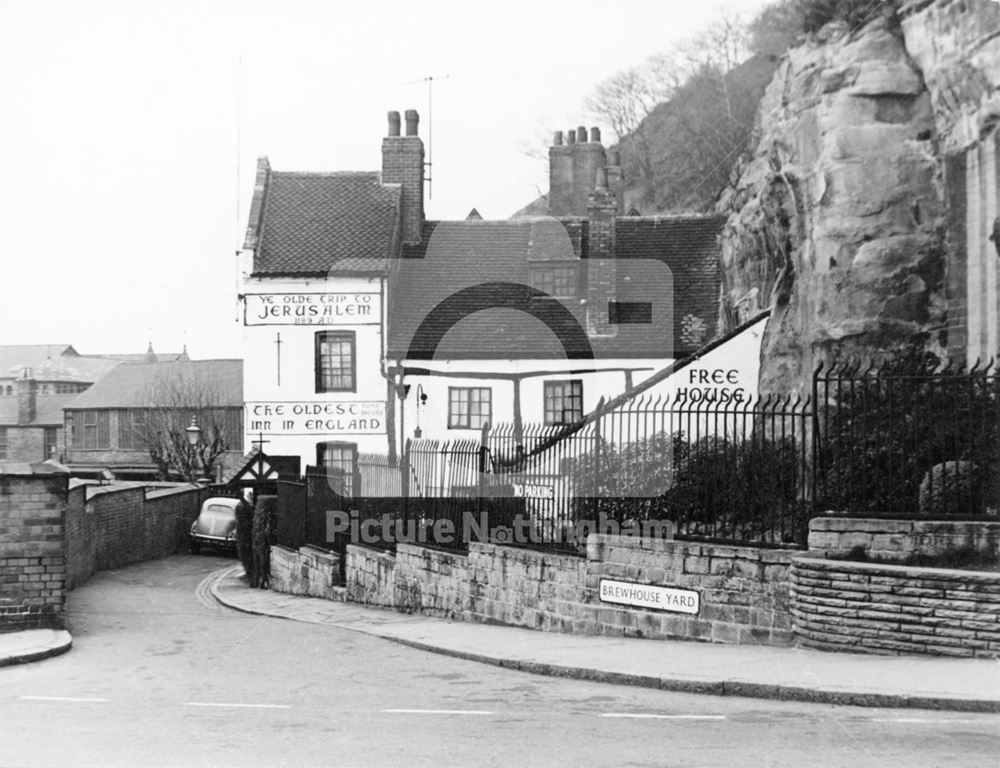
[389,216,725,359]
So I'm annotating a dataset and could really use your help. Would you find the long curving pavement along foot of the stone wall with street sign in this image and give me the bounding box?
[211,566,1000,712]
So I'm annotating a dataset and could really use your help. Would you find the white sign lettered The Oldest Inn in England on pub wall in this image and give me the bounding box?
[246,400,385,436]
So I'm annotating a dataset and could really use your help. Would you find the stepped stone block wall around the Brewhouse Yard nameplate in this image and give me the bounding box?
[345,535,796,645]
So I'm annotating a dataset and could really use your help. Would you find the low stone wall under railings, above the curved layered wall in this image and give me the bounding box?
[809,517,1000,560]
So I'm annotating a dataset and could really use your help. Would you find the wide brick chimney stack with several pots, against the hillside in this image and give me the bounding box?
[549,125,606,216]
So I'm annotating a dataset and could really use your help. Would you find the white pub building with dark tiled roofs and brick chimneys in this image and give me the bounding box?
[240,111,760,484]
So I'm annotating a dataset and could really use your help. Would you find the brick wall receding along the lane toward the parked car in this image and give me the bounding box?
[66,486,212,589]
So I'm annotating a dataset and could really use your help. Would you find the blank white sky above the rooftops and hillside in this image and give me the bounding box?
[0,0,766,358]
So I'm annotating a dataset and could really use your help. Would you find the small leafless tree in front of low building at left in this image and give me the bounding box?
[134,374,234,482]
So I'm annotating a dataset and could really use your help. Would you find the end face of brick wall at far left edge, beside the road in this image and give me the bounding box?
[0,473,69,632]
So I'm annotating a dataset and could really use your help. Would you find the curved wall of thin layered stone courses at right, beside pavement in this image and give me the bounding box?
[791,558,1000,657]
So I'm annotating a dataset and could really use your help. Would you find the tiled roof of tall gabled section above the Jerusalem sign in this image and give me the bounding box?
[246,170,401,275]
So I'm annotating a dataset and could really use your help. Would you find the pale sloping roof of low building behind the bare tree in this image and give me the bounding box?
[66,360,243,410]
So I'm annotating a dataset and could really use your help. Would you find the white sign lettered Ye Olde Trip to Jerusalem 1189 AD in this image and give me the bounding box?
[243,293,380,325]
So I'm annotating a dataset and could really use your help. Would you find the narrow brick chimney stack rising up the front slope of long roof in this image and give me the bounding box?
[587,166,618,336]
